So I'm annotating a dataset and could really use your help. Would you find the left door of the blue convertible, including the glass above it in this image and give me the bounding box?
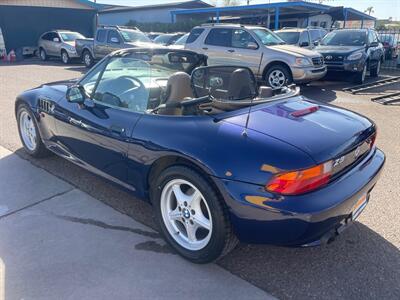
[51,58,149,188]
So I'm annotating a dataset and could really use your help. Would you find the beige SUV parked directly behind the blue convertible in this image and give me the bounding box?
[185,24,326,88]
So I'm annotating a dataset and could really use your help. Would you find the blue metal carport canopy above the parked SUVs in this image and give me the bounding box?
[171,1,375,29]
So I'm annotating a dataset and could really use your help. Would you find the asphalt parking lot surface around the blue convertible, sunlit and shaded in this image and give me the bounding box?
[0,60,400,299]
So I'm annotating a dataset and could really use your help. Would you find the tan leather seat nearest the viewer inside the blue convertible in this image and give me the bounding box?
[159,72,194,115]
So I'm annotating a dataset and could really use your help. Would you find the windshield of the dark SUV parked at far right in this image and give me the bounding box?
[321,30,367,46]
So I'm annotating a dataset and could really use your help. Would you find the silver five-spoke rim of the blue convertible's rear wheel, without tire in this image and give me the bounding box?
[160,179,213,251]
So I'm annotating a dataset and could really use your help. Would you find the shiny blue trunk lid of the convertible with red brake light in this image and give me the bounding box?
[220,96,375,163]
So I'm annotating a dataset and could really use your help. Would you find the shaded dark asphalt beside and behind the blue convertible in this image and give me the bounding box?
[12,149,400,299]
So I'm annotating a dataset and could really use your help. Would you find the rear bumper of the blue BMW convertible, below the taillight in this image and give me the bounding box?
[216,149,385,246]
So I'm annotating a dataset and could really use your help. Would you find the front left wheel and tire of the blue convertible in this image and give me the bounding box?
[17,104,50,158]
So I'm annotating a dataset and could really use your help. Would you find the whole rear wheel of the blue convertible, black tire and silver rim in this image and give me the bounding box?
[151,166,238,263]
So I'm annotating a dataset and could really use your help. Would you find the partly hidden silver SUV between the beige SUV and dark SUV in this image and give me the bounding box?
[275,27,328,49]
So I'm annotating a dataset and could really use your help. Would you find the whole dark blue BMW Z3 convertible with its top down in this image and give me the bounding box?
[15,48,385,263]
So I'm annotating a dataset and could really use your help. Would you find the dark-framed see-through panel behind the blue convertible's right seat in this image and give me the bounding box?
[192,66,257,101]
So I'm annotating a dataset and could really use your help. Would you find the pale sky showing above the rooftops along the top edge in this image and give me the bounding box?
[97,0,400,21]
